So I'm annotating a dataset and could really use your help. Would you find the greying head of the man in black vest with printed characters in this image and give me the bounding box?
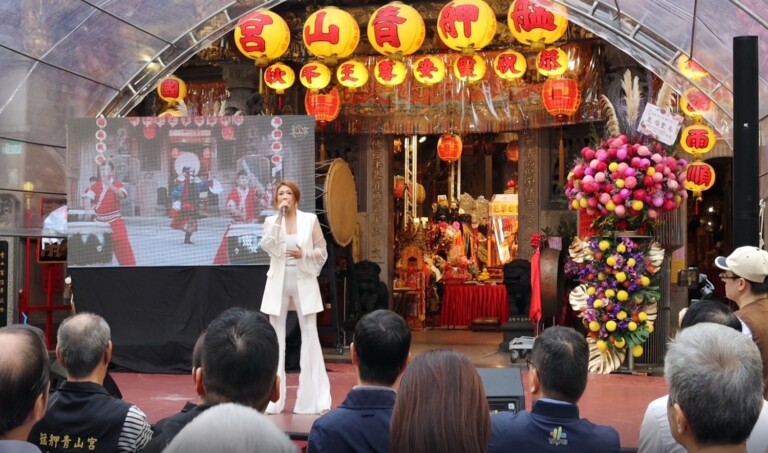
[56,313,112,384]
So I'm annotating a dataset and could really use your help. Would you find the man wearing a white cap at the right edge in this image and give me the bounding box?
[715,246,768,398]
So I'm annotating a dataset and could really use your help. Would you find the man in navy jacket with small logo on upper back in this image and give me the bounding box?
[488,326,621,453]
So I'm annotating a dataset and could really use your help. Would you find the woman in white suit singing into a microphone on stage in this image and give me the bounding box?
[261,181,331,414]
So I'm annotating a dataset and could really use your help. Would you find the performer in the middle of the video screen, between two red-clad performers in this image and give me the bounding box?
[171,167,208,244]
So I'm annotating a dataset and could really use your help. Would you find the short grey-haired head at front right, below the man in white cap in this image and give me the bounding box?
[664,323,763,451]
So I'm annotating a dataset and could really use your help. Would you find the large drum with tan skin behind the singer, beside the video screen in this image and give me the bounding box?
[315,159,357,247]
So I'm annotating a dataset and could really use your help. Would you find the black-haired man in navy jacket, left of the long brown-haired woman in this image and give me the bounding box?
[307,310,411,453]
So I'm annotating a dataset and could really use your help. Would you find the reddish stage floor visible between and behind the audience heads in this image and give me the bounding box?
[112,329,667,448]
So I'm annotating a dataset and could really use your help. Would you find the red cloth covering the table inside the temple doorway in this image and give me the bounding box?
[440,284,509,327]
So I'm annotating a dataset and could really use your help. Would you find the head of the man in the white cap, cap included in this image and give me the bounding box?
[715,246,768,308]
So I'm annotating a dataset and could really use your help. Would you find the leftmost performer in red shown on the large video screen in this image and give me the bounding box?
[83,162,136,266]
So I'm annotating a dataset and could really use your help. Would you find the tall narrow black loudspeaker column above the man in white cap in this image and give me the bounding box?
[731,36,761,248]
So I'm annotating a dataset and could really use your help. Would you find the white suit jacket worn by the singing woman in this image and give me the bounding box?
[261,209,328,316]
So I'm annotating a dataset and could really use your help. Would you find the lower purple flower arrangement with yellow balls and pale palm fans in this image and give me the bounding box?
[566,235,664,373]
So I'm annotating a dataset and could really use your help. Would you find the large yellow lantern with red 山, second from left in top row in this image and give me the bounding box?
[303,6,360,65]
